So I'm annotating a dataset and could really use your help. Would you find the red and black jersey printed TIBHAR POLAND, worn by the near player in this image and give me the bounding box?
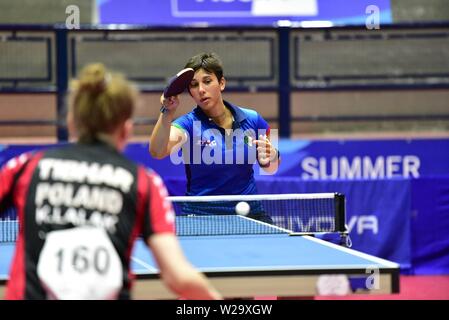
[0,142,174,299]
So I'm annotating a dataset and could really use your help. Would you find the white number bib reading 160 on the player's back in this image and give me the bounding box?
[37,227,123,300]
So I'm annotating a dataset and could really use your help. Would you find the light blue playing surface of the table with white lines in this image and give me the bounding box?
[0,216,399,279]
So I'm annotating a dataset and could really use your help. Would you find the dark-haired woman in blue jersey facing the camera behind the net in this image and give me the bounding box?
[150,53,280,222]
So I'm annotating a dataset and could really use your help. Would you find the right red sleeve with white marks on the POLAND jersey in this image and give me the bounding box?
[142,172,175,238]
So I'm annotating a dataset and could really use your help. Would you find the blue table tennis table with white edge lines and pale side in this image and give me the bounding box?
[0,215,399,299]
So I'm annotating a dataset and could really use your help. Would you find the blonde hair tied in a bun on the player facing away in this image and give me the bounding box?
[70,63,137,142]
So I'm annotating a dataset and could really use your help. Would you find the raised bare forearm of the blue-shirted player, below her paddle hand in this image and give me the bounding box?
[150,113,173,159]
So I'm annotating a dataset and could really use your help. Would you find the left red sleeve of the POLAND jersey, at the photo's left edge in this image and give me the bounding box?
[0,153,31,214]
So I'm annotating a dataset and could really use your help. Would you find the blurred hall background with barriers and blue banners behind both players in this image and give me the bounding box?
[0,0,449,299]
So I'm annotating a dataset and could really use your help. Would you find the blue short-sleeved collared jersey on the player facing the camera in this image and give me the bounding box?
[172,101,270,196]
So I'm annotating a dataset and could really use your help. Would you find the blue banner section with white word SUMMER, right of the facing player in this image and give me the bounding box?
[276,139,449,180]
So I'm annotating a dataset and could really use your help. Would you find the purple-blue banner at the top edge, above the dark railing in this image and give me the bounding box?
[97,0,392,26]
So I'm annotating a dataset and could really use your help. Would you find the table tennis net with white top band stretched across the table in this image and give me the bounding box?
[0,193,346,242]
